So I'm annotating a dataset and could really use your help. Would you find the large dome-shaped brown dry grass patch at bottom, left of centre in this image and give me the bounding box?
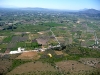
[7,61,57,75]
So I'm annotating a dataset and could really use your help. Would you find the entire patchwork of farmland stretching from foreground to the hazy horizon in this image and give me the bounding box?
[0,8,100,75]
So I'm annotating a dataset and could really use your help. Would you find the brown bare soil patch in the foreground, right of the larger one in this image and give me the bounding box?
[56,60,93,74]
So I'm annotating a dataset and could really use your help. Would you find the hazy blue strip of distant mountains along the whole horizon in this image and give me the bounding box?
[0,7,100,14]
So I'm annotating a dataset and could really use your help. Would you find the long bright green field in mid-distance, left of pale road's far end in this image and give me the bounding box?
[13,22,62,33]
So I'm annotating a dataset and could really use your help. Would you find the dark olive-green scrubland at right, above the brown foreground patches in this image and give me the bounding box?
[65,45,100,60]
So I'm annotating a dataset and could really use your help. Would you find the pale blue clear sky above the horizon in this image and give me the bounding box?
[0,0,100,10]
